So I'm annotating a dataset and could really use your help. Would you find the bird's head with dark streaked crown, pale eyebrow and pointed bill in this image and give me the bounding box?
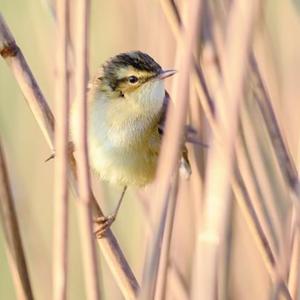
[97,51,175,109]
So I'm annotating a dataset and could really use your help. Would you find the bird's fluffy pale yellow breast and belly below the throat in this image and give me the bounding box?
[71,89,160,186]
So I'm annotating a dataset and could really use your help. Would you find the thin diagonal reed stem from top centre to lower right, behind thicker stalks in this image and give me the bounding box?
[161,0,290,290]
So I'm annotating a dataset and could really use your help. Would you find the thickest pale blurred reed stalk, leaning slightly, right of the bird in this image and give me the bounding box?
[192,1,258,300]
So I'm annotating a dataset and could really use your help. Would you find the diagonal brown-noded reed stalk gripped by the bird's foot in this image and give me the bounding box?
[0,14,139,299]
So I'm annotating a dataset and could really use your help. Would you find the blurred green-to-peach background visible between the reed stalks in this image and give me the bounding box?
[0,0,300,300]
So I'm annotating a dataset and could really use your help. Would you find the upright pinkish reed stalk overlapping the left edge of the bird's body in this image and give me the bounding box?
[74,0,100,300]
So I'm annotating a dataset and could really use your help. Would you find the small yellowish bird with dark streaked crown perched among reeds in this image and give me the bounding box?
[71,51,191,237]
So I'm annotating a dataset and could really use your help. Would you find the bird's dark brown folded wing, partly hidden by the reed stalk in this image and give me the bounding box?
[158,91,192,179]
